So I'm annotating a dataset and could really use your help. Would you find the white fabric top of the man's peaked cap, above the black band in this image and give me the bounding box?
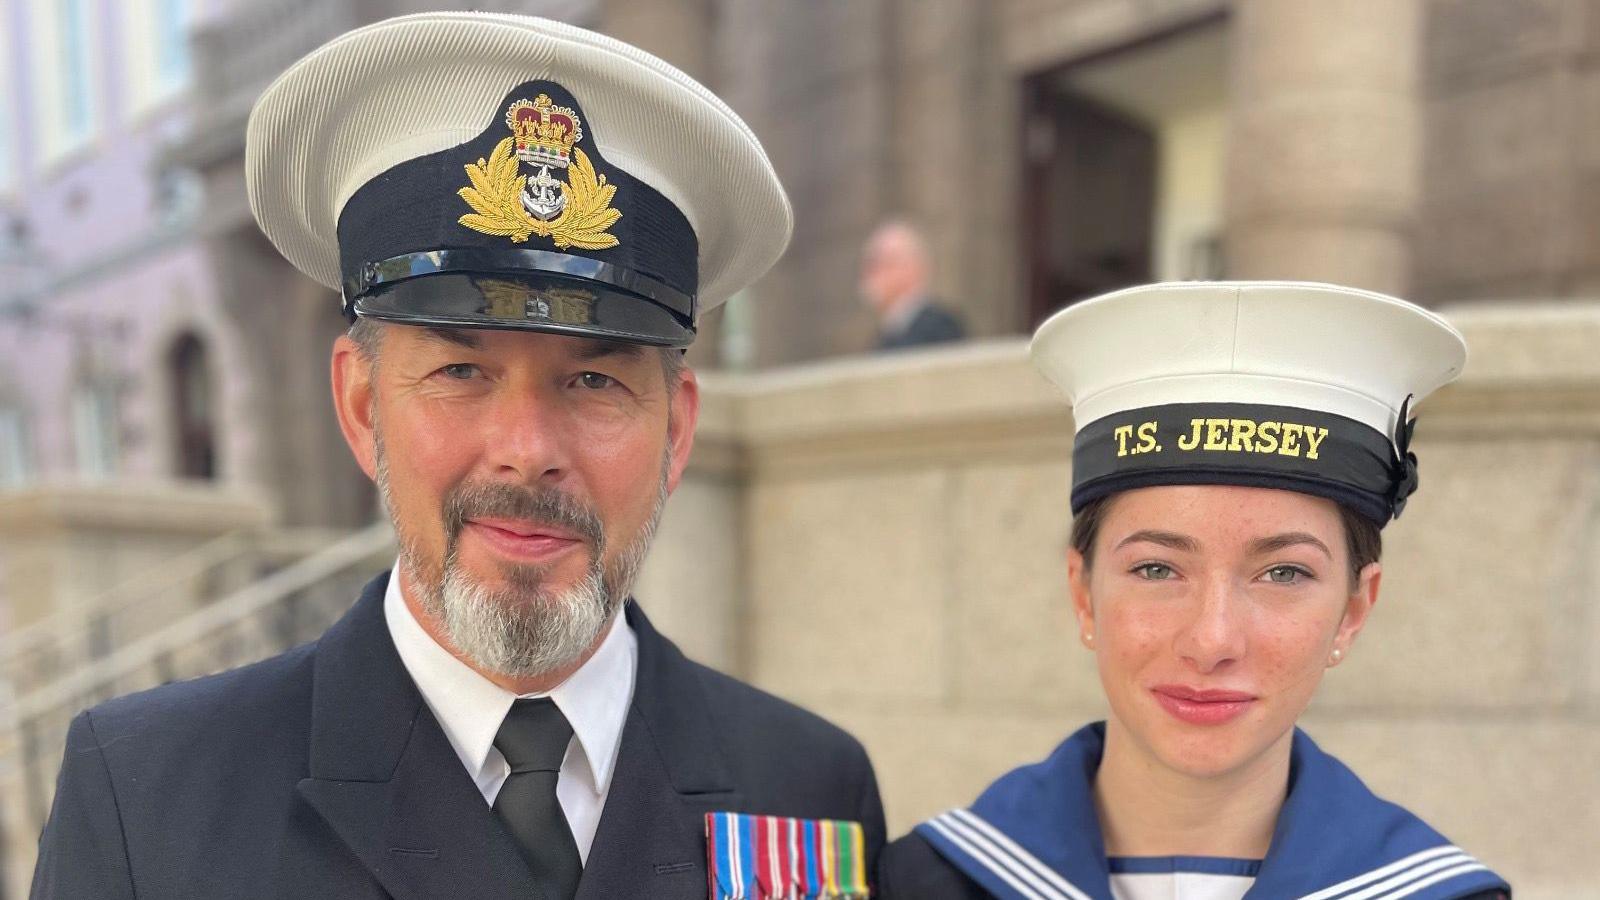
[245,13,792,328]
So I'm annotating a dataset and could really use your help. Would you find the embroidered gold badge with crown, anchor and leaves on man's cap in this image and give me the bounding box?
[456,94,622,250]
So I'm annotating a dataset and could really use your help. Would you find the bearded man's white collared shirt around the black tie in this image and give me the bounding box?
[384,562,638,863]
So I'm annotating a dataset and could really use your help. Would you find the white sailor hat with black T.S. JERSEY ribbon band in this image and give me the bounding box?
[1032,282,1467,525]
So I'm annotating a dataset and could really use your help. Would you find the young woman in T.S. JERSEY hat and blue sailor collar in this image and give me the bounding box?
[878,282,1510,900]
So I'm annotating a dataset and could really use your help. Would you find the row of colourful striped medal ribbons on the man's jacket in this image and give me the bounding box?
[706,812,869,900]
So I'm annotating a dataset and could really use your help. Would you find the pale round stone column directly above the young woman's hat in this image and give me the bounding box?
[1226,0,1421,295]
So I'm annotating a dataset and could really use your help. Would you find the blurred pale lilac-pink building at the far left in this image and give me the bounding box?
[0,0,242,485]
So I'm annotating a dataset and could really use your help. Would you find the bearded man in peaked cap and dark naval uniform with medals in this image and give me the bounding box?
[32,13,883,900]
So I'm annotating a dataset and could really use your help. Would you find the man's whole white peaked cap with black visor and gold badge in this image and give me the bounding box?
[245,13,792,346]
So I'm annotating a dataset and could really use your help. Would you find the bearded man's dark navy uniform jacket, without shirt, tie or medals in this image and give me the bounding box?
[32,575,883,900]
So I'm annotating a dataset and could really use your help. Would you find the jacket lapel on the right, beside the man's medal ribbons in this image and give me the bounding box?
[578,604,739,900]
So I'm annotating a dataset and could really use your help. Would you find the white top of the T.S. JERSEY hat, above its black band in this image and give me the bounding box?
[1030,282,1467,434]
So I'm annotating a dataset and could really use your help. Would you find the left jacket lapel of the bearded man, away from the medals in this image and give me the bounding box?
[288,575,541,900]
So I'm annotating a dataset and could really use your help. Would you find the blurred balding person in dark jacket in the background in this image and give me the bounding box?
[859,219,966,351]
